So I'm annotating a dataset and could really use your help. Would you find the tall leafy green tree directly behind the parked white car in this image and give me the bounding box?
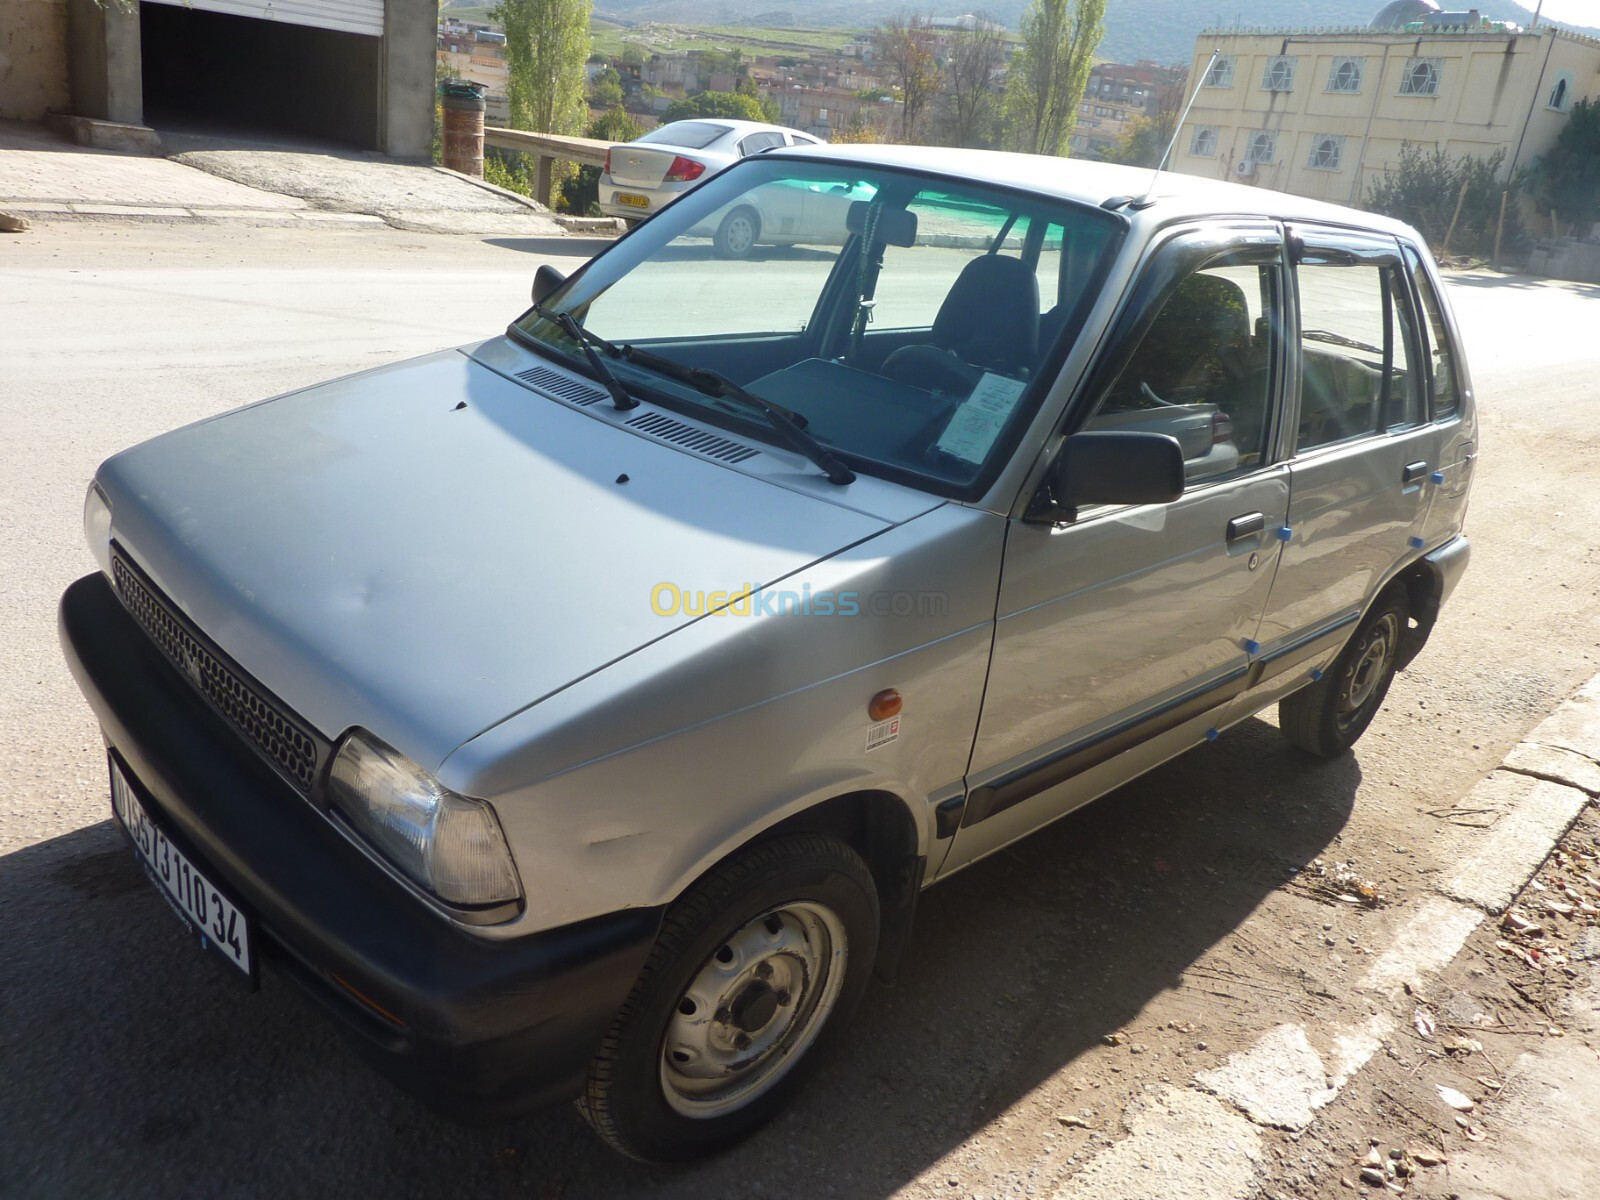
[491,0,592,134]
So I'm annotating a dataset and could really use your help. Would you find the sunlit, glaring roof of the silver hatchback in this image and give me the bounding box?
[762,144,1421,242]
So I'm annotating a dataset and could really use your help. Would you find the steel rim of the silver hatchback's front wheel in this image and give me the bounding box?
[661,901,848,1118]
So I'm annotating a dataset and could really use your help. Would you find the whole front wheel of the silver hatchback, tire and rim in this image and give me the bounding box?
[578,834,878,1162]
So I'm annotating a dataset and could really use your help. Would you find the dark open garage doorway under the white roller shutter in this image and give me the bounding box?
[139,2,382,150]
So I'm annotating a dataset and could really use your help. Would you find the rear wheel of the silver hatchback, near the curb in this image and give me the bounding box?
[1278,587,1411,758]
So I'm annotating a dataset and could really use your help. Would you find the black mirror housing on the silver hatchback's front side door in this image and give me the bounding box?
[1024,429,1184,525]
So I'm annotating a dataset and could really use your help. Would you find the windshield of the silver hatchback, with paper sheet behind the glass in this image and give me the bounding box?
[515,155,1123,496]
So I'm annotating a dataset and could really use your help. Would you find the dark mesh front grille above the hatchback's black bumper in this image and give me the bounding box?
[110,547,320,794]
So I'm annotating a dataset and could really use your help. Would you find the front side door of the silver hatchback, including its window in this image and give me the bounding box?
[944,227,1290,872]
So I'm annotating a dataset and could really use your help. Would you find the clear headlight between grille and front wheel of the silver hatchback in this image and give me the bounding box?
[328,730,522,904]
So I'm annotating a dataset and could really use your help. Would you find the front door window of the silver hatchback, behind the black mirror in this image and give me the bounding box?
[1086,264,1278,483]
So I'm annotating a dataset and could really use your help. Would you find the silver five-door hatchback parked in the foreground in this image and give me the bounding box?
[61,147,1477,1160]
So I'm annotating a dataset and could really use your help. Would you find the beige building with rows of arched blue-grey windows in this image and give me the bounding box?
[1173,14,1600,205]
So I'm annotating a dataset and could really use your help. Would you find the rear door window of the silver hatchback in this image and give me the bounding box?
[1296,261,1424,451]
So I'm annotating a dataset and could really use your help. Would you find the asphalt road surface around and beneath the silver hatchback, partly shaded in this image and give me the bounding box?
[0,224,1600,1200]
